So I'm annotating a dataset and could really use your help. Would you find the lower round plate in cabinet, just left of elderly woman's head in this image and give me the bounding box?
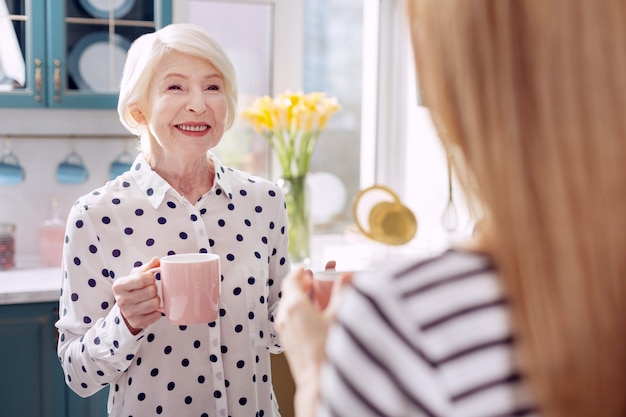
[67,32,130,93]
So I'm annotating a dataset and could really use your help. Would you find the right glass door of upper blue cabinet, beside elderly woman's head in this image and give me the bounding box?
[47,0,172,108]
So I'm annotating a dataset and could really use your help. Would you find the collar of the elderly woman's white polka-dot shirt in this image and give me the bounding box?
[130,153,233,209]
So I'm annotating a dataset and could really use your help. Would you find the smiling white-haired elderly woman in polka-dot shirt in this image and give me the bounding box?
[57,24,289,417]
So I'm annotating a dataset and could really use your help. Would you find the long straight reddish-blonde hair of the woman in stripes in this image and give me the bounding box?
[408,0,626,417]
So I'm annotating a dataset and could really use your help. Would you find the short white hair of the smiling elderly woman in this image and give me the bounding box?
[117,23,237,140]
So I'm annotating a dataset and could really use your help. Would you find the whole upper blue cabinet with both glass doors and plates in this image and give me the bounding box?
[0,0,172,109]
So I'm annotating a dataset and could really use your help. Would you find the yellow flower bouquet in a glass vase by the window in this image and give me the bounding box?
[242,92,341,262]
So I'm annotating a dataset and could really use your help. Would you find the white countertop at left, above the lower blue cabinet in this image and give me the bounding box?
[0,267,61,304]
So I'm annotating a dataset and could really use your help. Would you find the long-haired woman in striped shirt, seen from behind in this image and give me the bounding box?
[278,0,626,417]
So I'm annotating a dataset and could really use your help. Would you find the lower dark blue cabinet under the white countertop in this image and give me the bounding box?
[0,302,108,417]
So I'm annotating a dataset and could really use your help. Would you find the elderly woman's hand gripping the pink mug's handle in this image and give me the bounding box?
[113,257,161,334]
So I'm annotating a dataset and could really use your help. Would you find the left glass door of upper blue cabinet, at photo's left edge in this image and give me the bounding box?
[0,0,46,107]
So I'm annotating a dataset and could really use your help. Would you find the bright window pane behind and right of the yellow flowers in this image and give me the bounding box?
[303,0,360,232]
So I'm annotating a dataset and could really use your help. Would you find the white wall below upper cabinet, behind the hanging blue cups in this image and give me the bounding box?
[0,109,135,267]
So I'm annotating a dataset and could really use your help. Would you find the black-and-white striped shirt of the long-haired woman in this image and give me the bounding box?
[318,250,538,417]
